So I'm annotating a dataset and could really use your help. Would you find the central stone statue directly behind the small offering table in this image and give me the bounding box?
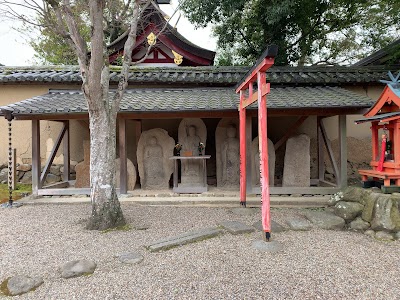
[178,118,207,184]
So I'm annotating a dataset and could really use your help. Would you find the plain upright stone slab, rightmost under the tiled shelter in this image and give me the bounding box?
[282,134,311,187]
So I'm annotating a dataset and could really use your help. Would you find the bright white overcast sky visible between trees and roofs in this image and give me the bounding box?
[0,0,216,66]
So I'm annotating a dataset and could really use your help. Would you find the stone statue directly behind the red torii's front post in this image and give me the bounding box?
[251,136,276,186]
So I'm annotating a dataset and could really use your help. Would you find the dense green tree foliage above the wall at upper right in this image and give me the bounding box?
[183,0,400,65]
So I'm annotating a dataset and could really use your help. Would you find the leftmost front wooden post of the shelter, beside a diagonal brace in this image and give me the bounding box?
[32,120,41,196]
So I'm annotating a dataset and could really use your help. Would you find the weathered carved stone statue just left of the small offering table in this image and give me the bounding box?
[137,128,175,190]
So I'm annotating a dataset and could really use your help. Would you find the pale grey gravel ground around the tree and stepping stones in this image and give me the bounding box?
[0,204,400,299]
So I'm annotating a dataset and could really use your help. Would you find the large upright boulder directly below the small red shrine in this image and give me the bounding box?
[371,194,395,231]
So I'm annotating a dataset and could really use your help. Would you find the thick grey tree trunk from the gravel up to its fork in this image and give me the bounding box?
[86,103,126,230]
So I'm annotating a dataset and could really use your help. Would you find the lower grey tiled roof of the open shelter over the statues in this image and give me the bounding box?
[1,87,374,115]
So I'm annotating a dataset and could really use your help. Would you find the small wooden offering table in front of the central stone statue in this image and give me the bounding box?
[169,155,211,194]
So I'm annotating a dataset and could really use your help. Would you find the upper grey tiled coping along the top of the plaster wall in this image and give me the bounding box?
[0,66,398,86]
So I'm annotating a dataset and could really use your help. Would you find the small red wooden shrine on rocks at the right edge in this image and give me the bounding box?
[356,72,400,193]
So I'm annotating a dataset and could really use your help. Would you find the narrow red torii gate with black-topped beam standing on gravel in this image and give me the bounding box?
[236,45,278,241]
